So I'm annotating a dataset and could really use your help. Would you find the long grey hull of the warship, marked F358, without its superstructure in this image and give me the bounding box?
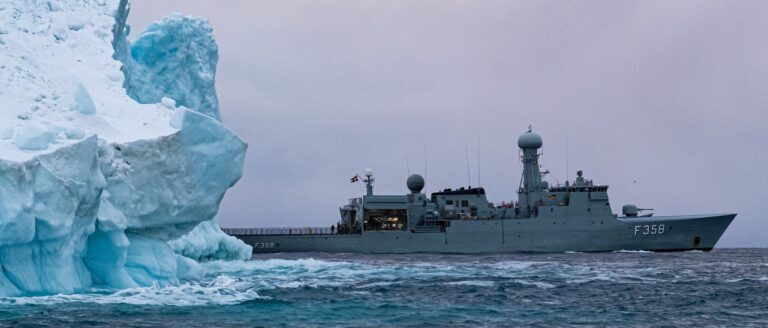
[235,214,736,254]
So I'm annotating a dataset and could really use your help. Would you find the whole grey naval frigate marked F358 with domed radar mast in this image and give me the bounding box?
[223,129,736,253]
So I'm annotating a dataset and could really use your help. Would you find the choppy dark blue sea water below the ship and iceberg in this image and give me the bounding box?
[0,249,768,327]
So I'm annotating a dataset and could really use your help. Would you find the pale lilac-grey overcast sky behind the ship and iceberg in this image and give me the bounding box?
[129,0,768,246]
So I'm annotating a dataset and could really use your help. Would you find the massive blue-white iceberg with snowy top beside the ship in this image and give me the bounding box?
[0,0,250,296]
